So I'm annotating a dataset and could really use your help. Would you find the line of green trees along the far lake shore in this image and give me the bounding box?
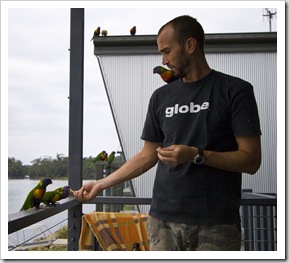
[8,154,120,179]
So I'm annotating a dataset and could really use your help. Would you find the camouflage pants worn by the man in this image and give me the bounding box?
[148,216,241,251]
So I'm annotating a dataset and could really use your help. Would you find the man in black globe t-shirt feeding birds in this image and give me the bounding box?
[76,16,261,250]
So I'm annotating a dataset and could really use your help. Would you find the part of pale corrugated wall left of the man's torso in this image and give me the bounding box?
[98,55,164,202]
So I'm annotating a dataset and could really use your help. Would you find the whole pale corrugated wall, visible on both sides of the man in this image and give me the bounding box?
[98,53,277,208]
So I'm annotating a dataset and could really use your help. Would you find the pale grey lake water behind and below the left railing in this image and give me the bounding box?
[8,179,95,248]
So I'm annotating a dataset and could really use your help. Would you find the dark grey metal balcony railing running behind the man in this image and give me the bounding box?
[8,192,277,251]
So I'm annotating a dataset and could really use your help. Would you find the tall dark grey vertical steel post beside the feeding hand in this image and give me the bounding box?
[68,8,84,250]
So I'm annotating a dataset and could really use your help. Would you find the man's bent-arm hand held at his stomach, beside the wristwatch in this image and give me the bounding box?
[157,145,197,165]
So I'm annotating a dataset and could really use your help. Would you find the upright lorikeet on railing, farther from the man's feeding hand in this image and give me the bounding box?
[20,178,52,211]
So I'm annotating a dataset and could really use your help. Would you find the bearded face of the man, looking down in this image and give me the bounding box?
[157,25,191,78]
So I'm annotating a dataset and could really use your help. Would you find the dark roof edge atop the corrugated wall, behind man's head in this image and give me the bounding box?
[93,32,277,55]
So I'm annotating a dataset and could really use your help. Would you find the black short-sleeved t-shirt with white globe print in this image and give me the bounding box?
[141,70,261,224]
